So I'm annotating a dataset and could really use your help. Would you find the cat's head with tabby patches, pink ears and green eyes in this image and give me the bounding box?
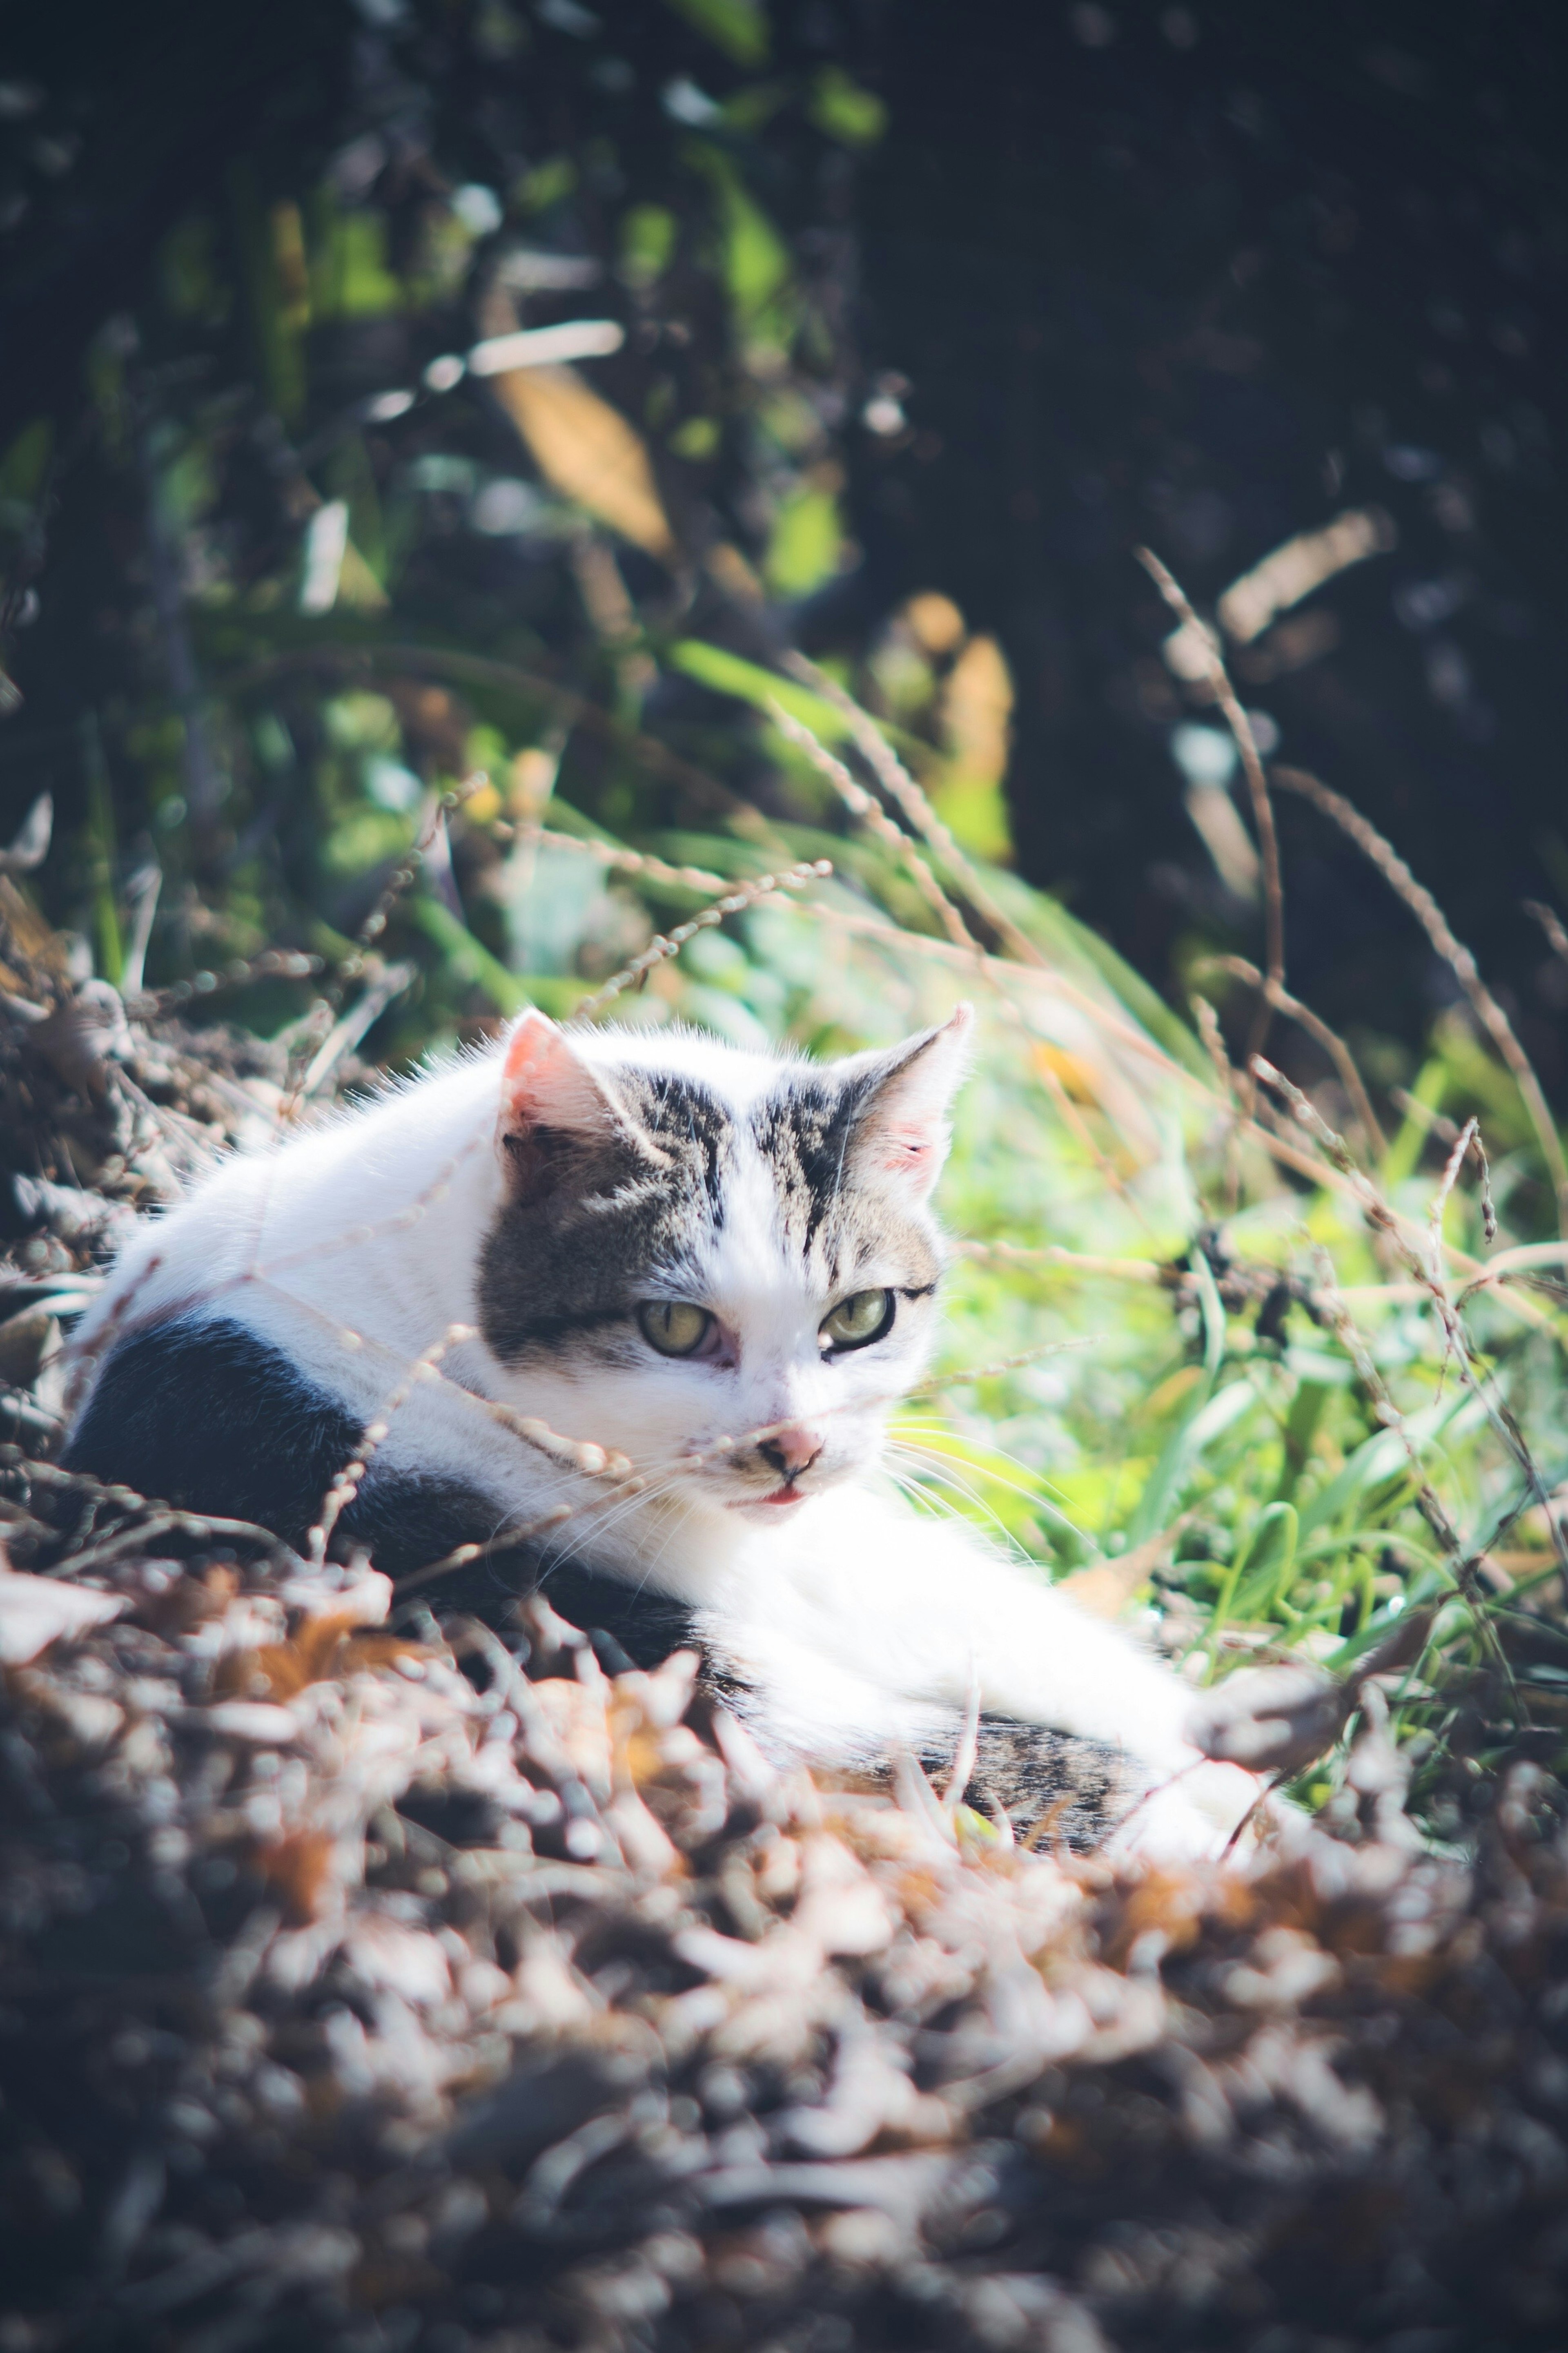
[479,1005,971,1522]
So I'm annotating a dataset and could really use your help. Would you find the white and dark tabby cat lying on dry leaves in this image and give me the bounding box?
[63,1007,1260,1856]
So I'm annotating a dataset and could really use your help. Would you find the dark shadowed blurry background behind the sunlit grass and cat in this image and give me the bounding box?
[0,0,1568,1097]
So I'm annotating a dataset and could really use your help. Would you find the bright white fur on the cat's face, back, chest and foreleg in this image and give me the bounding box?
[80,1030,1258,1856]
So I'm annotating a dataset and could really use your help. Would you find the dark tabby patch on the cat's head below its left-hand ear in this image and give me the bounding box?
[479,1071,731,1365]
